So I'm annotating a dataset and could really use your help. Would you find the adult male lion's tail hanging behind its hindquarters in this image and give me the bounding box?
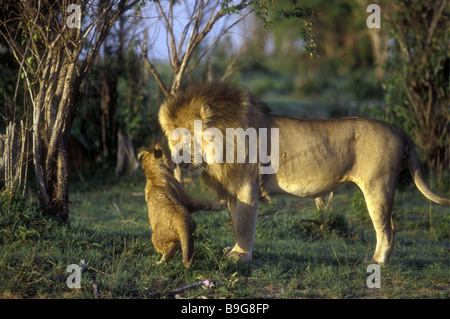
[405,134,450,206]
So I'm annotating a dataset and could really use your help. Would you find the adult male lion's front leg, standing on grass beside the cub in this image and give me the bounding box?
[226,185,258,262]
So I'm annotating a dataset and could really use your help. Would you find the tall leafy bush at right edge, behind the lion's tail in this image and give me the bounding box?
[379,0,450,172]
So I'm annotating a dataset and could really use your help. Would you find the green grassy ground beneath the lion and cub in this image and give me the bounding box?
[0,175,450,299]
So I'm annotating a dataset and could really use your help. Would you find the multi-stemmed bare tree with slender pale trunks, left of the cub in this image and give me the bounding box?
[0,0,138,219]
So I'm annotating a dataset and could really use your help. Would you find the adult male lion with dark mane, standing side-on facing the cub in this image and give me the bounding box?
[159,83,449,263]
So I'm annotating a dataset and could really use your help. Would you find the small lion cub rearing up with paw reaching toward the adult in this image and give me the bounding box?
[138,145,226,268]
